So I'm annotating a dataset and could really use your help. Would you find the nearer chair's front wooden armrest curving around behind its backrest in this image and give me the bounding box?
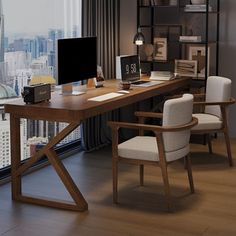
[108,117,198,133]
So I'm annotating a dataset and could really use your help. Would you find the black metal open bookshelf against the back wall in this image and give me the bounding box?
[137,0,220,86]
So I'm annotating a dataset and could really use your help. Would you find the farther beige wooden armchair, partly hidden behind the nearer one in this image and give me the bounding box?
[191,76,235,166]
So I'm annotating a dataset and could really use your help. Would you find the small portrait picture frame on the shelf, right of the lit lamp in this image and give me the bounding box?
[153,37,167,61]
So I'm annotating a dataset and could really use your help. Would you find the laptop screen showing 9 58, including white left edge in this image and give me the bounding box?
[116,55,140,81]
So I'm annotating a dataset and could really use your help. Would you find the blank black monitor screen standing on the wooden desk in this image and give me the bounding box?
[56,37,97,85]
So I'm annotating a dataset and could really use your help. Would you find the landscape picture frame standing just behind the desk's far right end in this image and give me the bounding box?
[175,60,197,77]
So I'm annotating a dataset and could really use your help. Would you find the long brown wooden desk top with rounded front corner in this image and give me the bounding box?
[5,78,190,122]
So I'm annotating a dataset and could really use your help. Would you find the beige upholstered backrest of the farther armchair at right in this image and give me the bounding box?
[205,76,231,118]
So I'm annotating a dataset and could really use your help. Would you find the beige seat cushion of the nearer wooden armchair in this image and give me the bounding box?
[118,136,189,161]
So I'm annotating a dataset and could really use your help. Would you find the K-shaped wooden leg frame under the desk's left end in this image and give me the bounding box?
[10,114,88,211]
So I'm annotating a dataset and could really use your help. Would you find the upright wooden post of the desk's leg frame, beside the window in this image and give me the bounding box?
[10,114,21,200]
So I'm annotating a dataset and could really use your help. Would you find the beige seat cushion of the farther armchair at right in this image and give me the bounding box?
[192,113,222,130]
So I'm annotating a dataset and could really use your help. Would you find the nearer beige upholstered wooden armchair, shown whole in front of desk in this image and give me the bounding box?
[109,94,197,209]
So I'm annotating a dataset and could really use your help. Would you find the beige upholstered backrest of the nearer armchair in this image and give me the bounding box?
[162,94,193,152]
